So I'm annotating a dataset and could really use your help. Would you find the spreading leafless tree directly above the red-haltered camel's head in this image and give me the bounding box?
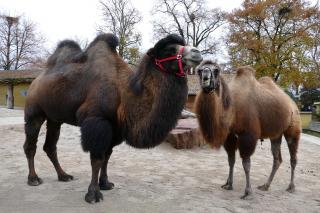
[153,0,226,54]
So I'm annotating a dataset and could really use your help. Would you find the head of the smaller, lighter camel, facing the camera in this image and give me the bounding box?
[196,60,221,92]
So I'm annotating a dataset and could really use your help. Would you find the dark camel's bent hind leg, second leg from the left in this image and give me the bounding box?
[43,119,73,181]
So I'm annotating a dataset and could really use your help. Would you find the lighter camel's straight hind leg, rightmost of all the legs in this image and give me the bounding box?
[285,132,300,193]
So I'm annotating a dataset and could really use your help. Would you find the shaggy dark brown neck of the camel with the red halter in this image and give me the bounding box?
[124,74,188,148]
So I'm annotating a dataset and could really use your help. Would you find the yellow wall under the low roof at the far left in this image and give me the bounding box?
[0,83,30,107]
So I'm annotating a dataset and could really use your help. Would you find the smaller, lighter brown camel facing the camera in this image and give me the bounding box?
[195,61,301,198]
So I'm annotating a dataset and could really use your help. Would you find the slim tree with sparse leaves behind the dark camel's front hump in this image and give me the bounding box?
[98,0,142,60]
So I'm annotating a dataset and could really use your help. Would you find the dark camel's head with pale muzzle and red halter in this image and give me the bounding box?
[147,34,202,77]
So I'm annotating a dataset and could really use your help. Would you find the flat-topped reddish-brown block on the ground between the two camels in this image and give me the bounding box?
[166,118,205,149]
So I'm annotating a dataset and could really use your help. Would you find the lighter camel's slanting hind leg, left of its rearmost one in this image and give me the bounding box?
[258,135,282,191]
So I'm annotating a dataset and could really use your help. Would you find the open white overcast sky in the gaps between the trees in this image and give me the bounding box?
[0,0,242,50]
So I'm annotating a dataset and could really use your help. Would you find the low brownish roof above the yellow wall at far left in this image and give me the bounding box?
[0,69,43,84]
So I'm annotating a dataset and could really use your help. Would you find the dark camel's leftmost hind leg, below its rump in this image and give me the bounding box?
[23,114,45,186]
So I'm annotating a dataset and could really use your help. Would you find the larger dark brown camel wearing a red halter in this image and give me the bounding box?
[24,34,202,203]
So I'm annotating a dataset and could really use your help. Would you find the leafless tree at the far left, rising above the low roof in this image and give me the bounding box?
[0,15,44,109]
